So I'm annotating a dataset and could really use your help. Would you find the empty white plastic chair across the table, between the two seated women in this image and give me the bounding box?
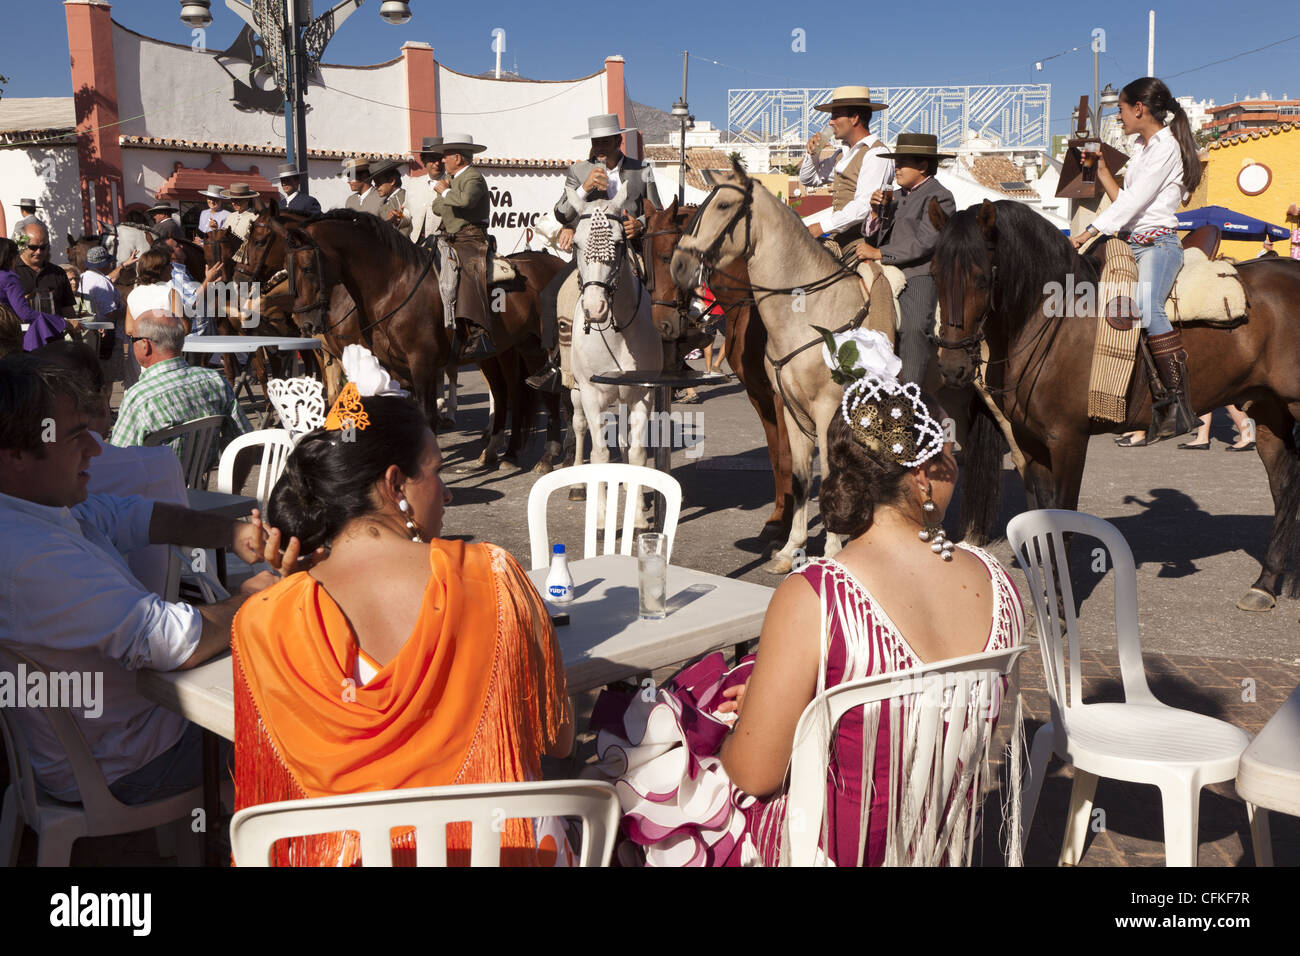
[528,462,681,568]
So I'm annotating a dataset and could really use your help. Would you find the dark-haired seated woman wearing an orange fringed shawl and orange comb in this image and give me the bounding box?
[233,385,573,865]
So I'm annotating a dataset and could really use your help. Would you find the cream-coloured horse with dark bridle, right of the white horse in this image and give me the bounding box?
[671,165,867,574]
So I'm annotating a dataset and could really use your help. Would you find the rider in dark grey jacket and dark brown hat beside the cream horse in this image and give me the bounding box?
[858,133,957,386]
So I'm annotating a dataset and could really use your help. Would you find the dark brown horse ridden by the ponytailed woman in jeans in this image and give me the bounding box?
[933,200,1300,611]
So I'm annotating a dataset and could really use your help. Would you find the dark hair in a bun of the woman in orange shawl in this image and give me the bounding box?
[267,395,429,554]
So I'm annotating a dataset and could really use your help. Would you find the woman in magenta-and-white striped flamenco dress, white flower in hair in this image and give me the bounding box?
[589,330,1024,866]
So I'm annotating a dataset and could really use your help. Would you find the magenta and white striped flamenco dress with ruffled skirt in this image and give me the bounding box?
[588,544,1024,866]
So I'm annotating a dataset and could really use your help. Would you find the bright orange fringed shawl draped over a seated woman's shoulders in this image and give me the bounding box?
[231,541,567,866]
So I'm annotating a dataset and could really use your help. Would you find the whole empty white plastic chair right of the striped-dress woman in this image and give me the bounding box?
[1006,511,1268,866]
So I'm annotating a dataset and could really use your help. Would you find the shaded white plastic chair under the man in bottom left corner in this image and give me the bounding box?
[0,646,203,866]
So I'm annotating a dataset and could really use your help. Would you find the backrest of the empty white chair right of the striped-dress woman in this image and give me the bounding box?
[1006,510,1158,730]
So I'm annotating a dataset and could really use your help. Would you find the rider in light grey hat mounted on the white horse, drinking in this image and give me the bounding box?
[528,113,660,392]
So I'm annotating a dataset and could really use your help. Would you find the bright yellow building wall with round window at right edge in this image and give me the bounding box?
[1188,125,1300,259]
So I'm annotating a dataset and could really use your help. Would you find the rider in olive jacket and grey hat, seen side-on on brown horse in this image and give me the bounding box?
[430,133,503,363]
